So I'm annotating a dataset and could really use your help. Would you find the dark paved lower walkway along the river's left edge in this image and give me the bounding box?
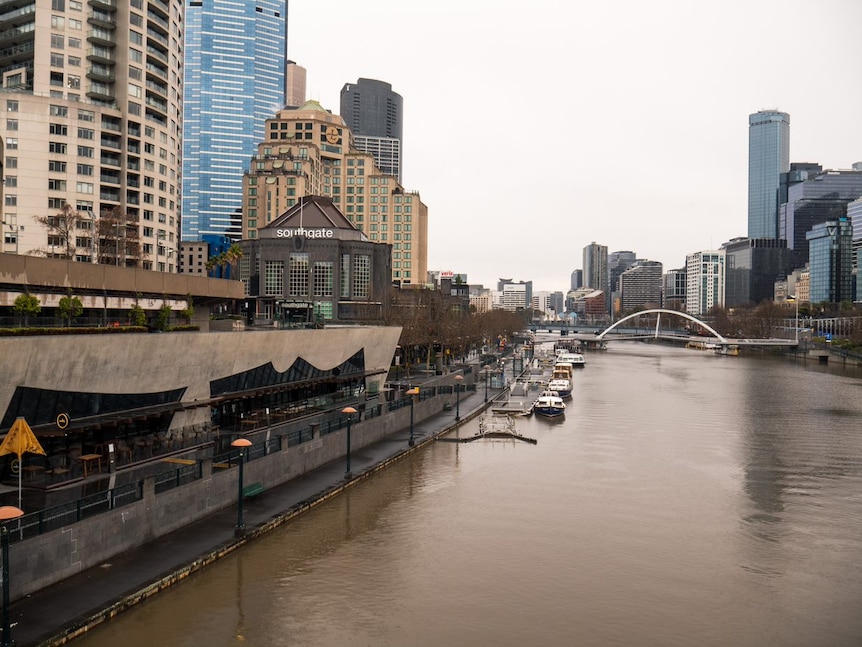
[9,368,499,647]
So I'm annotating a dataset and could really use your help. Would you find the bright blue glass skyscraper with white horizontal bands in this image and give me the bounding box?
[182,0,287,240]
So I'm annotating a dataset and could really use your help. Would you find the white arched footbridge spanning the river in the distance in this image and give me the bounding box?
[530,308,799,353]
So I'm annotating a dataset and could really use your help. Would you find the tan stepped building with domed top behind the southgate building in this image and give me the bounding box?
[243,101,428,284]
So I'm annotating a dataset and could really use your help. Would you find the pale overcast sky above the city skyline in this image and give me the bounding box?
[288,0,862,292]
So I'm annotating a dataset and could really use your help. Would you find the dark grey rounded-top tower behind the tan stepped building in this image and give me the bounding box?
[341,79,404,182]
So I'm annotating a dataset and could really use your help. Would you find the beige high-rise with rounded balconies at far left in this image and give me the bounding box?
[0,0,184,272]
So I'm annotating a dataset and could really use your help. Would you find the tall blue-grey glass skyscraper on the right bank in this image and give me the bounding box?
[748,110,790,238]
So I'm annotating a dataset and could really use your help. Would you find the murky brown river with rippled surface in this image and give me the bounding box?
[74,343,862,647]
